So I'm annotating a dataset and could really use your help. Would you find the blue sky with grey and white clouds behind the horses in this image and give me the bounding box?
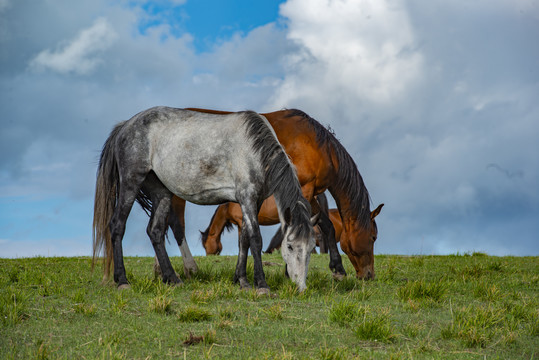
[0,0,539,258]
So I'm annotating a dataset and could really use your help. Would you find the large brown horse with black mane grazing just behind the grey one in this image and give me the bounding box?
[173,109,383,279]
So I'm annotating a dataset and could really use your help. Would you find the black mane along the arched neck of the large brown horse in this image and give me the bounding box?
[285,109,370,228]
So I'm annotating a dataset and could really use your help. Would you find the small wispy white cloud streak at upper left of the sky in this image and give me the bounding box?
[30,18,117,74]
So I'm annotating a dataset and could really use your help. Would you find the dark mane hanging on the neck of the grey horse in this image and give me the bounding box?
[244,111,311,236]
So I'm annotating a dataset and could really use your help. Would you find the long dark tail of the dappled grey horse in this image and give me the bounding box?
[92,122,125,281]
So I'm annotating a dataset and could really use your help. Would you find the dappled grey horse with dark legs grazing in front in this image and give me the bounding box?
[93,107,314,293]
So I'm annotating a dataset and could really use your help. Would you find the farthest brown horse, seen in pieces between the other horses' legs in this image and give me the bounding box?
[200,193,328,255]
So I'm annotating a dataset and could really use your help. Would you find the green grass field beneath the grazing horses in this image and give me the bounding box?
[0,253,539,359]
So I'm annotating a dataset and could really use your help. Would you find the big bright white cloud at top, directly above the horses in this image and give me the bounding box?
[273,0,422,106]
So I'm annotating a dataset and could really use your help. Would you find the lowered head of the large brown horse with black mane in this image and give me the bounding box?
[341,204,384,280]
